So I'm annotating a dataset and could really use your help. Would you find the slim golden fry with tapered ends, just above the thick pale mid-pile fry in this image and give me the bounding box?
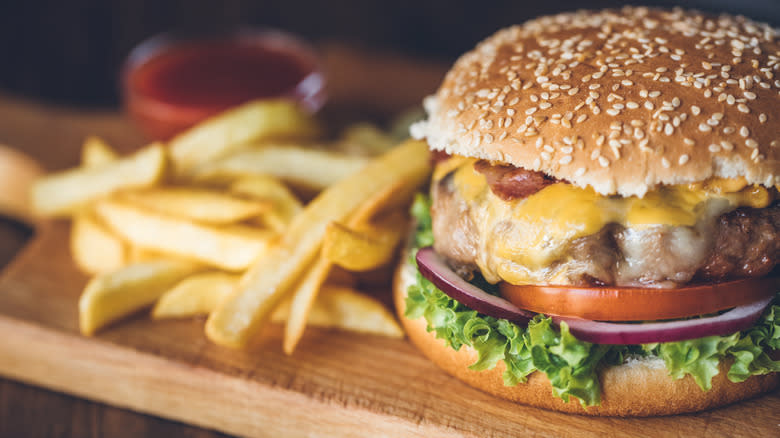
[119,187,272,225]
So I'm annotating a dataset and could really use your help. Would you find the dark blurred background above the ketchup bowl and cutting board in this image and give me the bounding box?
[0,0,780,106]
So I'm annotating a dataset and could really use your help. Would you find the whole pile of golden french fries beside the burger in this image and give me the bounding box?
[31,101,430,354]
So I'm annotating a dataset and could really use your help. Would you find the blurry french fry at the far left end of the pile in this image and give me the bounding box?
[32,144,166,216]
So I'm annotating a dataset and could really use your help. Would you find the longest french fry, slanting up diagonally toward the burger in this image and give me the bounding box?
[206,141,430,347]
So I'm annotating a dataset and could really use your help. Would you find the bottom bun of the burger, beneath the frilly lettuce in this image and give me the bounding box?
[393,253,780,416]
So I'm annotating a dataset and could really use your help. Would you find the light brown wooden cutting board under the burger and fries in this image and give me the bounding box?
[0,49,780,437]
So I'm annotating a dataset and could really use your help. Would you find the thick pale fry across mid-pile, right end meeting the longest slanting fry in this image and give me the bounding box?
[95,200,275,271]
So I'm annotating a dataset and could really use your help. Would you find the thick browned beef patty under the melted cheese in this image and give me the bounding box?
[431,173,780,287]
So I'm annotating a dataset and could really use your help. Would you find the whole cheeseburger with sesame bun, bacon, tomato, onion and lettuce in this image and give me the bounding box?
[394,7,780,416]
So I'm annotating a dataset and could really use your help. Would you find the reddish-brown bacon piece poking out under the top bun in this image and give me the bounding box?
[474,160,557,201]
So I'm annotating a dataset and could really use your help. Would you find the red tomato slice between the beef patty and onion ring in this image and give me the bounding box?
[499,277,780,321]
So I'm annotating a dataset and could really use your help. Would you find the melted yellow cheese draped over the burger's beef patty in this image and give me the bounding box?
[434,157,775,284]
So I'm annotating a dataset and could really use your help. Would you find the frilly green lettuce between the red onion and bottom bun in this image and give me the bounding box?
[405,194,780,406]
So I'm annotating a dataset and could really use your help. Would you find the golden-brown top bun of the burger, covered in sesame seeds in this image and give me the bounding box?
[412,7,780,196]
